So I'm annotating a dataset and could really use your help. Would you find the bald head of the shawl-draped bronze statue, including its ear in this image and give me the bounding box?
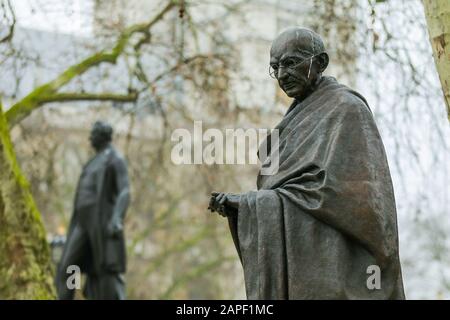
[270,27,329,100]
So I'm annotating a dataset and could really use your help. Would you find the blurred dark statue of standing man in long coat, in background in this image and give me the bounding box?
[56,121,130,300]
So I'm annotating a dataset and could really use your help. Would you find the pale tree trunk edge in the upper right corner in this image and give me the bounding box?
[423,0,450,121]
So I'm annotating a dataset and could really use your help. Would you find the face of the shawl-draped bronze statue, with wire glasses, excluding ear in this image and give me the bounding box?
[270,31,322,99]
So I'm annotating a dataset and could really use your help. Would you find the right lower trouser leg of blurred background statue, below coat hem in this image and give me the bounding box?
[85,271,125,300]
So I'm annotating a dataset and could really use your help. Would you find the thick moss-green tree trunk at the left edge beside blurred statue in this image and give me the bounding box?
[0,105,55,299]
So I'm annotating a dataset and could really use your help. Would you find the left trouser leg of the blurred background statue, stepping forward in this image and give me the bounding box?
[56,226,89,300]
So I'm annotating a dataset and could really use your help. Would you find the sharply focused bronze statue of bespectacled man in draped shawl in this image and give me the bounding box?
[209,27,404,299]
